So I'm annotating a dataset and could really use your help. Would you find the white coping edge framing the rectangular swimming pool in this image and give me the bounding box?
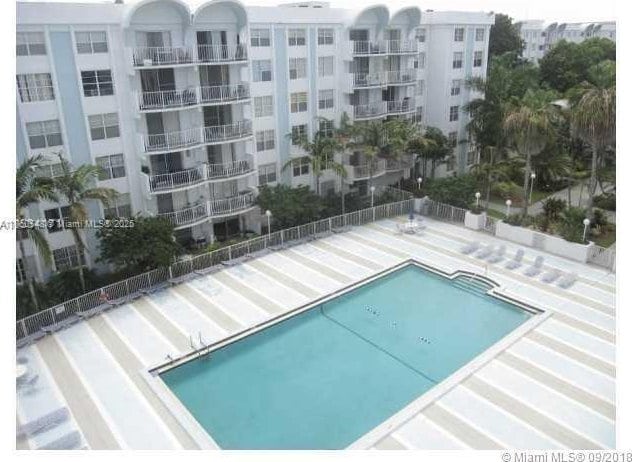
[139,258,552,449]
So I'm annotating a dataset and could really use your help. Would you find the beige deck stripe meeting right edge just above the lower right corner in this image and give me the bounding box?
[497,351,615,421]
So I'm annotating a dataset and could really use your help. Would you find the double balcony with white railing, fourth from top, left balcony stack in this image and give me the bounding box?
[148,154,254,194]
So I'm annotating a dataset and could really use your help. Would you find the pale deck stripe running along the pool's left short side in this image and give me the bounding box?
[88,317,199,449]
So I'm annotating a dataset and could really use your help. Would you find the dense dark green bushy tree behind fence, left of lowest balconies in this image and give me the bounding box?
[97,216,181,275]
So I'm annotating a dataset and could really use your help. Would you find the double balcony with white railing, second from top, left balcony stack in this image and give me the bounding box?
[137,83,250,112]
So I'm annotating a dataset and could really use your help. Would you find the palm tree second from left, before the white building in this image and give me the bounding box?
[54,154,118,291]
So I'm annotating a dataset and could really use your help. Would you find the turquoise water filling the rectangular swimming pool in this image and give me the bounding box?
[161,265,530,449]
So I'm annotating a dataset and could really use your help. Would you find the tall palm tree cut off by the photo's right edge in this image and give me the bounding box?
[571,85,616,215]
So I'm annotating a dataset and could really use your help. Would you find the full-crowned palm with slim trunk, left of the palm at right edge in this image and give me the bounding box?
[503,90,555,215]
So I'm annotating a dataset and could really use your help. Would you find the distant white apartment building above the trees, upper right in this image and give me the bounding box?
[517,20,617,62]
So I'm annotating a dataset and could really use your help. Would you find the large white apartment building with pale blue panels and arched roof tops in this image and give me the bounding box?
[16,0,494,281]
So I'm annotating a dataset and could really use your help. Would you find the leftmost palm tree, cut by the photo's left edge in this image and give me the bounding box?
[15,155,57,311]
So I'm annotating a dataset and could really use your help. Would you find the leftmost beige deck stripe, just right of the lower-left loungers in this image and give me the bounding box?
[37,335,121,449]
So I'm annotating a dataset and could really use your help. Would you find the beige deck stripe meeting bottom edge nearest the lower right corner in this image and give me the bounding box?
[462,375,599,449]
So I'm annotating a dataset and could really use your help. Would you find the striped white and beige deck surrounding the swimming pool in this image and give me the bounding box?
[16,217,616,449]
